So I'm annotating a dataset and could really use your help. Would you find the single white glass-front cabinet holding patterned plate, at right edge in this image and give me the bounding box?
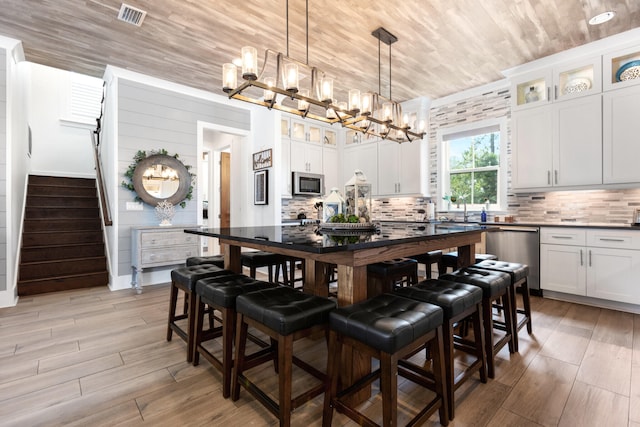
[602,46,640,90]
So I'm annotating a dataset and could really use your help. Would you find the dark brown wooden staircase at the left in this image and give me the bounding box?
[18,175,109,296]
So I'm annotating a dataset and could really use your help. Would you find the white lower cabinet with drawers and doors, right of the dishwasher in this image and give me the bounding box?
[540,227,640,304]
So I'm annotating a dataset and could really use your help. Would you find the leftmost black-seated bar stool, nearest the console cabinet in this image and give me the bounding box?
[167,264,233,362]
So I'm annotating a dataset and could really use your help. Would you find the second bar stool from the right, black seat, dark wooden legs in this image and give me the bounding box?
[439,267,515,378]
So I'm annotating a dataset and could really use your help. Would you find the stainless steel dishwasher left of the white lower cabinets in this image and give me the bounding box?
[487,225,542,295]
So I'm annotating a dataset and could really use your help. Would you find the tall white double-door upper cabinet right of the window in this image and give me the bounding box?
[512,95,602,190]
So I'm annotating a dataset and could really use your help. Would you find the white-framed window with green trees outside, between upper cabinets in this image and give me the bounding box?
[438,120,507,210]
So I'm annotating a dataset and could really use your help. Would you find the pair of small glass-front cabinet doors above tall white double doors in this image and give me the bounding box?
[512,56,602,109]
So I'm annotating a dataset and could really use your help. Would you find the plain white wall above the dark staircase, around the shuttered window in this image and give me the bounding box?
[28,63,95,178]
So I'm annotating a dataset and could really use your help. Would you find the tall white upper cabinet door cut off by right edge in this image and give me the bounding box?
[602,83,640,184]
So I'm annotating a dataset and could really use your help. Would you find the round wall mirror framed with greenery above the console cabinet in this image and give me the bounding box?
[132,154,191,206]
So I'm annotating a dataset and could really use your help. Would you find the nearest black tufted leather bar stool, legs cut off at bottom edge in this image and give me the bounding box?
[322,294,449,426]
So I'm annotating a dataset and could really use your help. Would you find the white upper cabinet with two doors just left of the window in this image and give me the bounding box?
[376,140,427,196]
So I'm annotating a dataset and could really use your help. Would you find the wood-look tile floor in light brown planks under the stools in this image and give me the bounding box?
[0,285,640,427]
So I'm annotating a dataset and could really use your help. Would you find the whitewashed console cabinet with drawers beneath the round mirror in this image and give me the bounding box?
[131,225,200,293]
